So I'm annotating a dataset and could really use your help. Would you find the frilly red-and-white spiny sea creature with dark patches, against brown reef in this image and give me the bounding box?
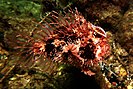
[15,9,110,75]
